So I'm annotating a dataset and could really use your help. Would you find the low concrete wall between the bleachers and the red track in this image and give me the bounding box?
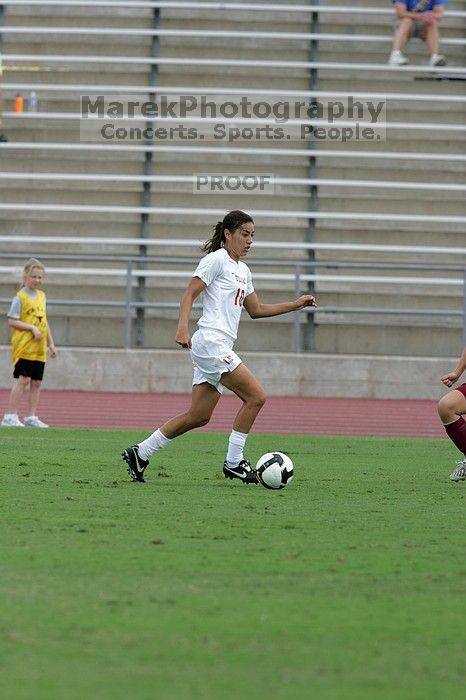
[0,345,459,400]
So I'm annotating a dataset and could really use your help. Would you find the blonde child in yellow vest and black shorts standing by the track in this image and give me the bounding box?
[1,258,57,428]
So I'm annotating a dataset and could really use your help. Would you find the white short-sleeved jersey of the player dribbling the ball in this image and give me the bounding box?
[193,248,254,340]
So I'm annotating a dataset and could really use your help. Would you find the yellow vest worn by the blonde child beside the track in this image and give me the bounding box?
[11,289,47,365]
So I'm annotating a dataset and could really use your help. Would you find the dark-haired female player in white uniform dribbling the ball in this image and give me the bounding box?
[122,210,316,483]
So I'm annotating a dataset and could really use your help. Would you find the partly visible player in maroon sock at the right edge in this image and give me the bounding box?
[438,348,466,481]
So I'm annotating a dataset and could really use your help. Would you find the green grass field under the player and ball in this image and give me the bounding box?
[0,429,466,700]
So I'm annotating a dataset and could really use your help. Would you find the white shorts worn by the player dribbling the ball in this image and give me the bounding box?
[191,329,242,394]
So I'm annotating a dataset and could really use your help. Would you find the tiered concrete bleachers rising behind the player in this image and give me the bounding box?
[0,1,466,355]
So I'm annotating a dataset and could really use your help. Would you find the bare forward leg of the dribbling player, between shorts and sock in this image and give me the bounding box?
[221,364,267,433]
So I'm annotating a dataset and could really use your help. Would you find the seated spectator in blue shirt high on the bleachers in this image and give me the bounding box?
[388,0,448,66]
